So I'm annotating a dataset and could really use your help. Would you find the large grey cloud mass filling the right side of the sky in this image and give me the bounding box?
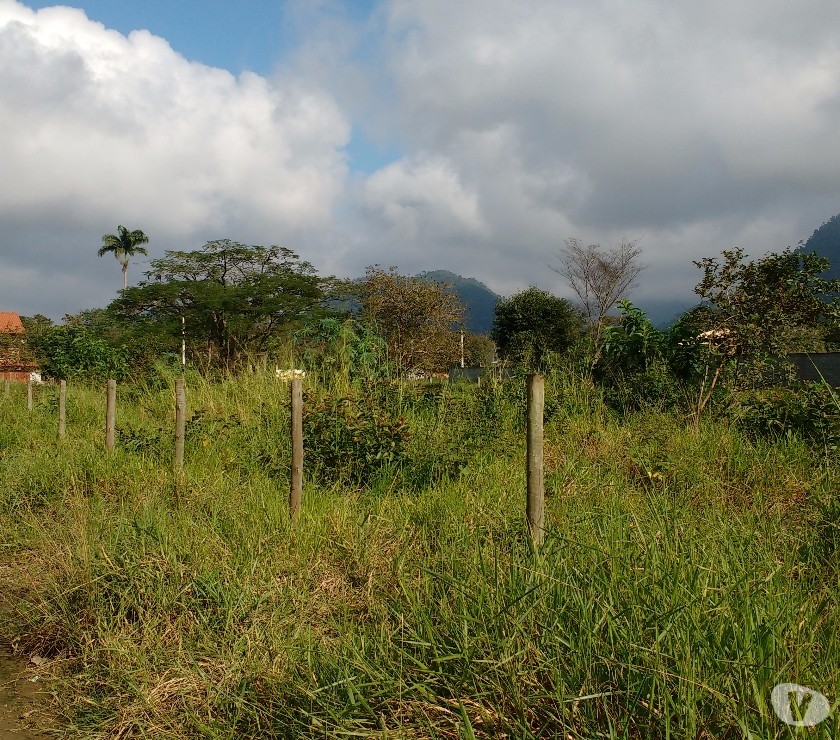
[342,0,840,312]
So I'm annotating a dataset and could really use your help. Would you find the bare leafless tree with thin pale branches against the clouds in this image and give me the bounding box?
[552,238,645,370]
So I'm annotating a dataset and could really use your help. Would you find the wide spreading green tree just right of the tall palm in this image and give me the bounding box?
[111,239,323,368]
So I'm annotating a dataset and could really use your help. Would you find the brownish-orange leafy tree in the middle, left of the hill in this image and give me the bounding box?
[355,266,464,372]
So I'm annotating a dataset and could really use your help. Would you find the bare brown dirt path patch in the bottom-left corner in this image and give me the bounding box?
[0,644,51,740]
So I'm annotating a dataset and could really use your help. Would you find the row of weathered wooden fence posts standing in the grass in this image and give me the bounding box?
[4,373,545,547]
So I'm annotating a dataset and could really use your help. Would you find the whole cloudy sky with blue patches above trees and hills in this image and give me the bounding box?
[0,0,840,321]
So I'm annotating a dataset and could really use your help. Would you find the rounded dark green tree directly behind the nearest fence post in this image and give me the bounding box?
[490,286,582,368]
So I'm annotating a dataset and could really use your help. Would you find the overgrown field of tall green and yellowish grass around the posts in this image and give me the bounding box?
[0,374,840,739]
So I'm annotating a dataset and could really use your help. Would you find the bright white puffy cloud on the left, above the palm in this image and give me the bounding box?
[0,0,349,320]
